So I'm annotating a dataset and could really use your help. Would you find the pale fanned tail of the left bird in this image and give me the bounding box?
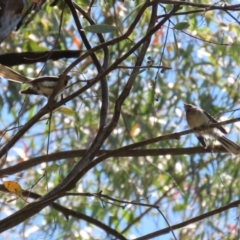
[0,64,31,83]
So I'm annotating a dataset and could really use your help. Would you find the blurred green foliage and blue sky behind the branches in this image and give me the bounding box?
[0,0,240,239]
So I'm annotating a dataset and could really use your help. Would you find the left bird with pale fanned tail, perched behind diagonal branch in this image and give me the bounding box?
[0,64,70,97]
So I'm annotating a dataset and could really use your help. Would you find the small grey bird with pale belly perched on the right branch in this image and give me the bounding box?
[184,103,240,155]
